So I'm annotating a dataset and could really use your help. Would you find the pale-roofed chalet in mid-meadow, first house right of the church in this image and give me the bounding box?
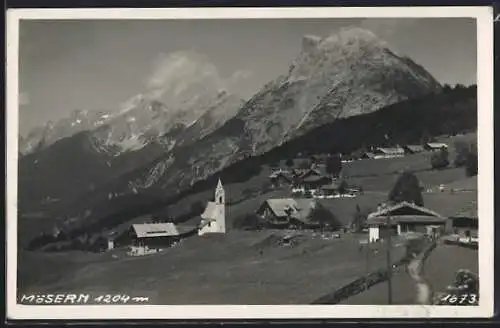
[256,198,335,229]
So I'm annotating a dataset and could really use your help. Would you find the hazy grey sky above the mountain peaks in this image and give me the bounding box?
[19,18,477,135]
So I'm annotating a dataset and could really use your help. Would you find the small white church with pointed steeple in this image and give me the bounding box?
[198,179,226,236]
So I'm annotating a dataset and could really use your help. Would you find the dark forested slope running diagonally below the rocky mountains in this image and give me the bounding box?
[24,87,477,247]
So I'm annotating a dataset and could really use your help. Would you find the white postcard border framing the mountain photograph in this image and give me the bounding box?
[6,7,494,320]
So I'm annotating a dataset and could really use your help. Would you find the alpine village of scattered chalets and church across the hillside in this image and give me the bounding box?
[104,138,478,255]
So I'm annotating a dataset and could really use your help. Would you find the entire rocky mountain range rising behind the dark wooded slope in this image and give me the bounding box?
[19,28,442,227]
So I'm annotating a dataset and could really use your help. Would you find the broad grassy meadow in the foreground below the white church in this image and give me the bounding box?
[20,231,404,304]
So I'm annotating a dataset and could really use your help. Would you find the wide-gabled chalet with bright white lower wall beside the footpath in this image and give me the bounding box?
[366,202,447,242]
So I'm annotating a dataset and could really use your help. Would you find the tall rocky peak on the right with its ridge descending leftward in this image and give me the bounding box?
[17,29,442,223]
